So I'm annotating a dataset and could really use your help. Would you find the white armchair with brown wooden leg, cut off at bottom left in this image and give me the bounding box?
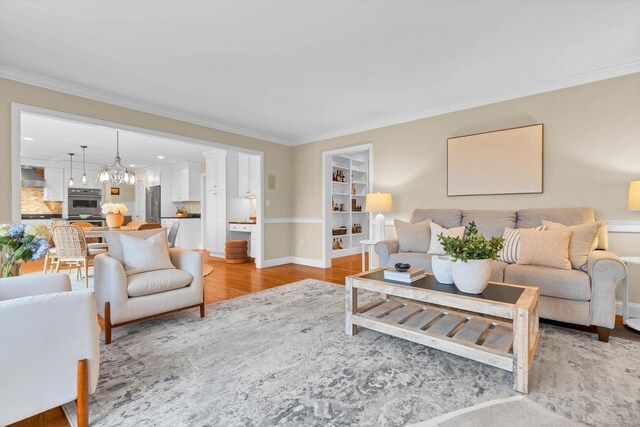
[0,274,100,426]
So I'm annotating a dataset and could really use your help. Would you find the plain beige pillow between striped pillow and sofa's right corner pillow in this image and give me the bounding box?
[517,229,571,270]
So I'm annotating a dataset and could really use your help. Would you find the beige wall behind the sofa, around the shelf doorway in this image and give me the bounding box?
[293,74,640,302]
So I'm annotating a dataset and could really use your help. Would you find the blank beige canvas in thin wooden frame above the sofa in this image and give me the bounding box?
[447,124,543,196]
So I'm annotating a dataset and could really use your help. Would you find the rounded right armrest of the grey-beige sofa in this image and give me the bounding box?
[587,250,627,329]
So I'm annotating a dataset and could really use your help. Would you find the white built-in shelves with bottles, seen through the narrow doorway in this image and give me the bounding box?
[329,155,369,258]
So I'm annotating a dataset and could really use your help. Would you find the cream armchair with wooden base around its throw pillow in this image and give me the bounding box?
[94,229,204,344]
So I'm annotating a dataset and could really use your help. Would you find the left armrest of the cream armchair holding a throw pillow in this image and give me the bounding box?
[93,254,129,317]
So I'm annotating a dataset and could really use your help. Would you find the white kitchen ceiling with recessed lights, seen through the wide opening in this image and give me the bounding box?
[20,113,212,170]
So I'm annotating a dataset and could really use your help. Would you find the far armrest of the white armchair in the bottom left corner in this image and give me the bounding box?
[0,273,71,301]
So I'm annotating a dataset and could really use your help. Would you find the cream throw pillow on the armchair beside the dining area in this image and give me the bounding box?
[120,233,175,276]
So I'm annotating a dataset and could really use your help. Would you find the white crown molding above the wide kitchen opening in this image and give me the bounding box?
[0,66,293,146]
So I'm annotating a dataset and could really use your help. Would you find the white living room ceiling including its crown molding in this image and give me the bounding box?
[0,0,640,143]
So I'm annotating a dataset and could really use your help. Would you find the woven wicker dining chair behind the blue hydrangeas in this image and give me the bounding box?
[51,225,107,288]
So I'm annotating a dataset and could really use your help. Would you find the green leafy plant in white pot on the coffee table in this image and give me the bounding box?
[438,221,504,262]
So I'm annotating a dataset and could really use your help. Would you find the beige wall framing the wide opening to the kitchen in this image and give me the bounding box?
[0,78,293,259]
